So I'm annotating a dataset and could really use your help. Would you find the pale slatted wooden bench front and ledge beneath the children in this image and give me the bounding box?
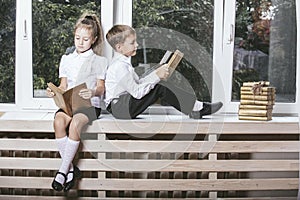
[0,111,300,200]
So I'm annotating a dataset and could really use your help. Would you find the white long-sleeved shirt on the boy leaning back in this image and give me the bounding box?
[105,52,160,106]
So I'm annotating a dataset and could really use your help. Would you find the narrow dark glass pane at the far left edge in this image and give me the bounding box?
[0,0,16,103]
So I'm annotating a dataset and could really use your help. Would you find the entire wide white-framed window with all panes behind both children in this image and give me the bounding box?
[0,0,300,113]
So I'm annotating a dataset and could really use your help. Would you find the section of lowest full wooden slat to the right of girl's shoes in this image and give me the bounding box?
[79,178,299,191]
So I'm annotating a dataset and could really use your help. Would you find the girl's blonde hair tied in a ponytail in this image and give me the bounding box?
[74,13,104,55]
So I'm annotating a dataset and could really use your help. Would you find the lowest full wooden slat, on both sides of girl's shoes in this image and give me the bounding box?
[0,176,299,191]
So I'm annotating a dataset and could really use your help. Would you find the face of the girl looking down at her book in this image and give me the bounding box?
[74,27,96,53]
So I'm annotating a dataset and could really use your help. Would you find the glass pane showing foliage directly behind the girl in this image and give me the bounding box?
[32,0,101,97]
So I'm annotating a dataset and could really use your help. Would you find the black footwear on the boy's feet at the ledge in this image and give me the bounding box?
[189,102,223,119]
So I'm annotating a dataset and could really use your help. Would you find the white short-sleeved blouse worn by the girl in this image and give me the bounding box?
[59,49,108,108]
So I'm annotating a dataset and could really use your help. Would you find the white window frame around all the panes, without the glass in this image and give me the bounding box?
[0,0,300,113]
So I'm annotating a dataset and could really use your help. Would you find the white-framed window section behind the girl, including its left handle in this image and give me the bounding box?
[12,0,106,110]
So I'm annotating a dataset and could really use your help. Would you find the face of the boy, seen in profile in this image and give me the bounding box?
[116,34,138,57]
